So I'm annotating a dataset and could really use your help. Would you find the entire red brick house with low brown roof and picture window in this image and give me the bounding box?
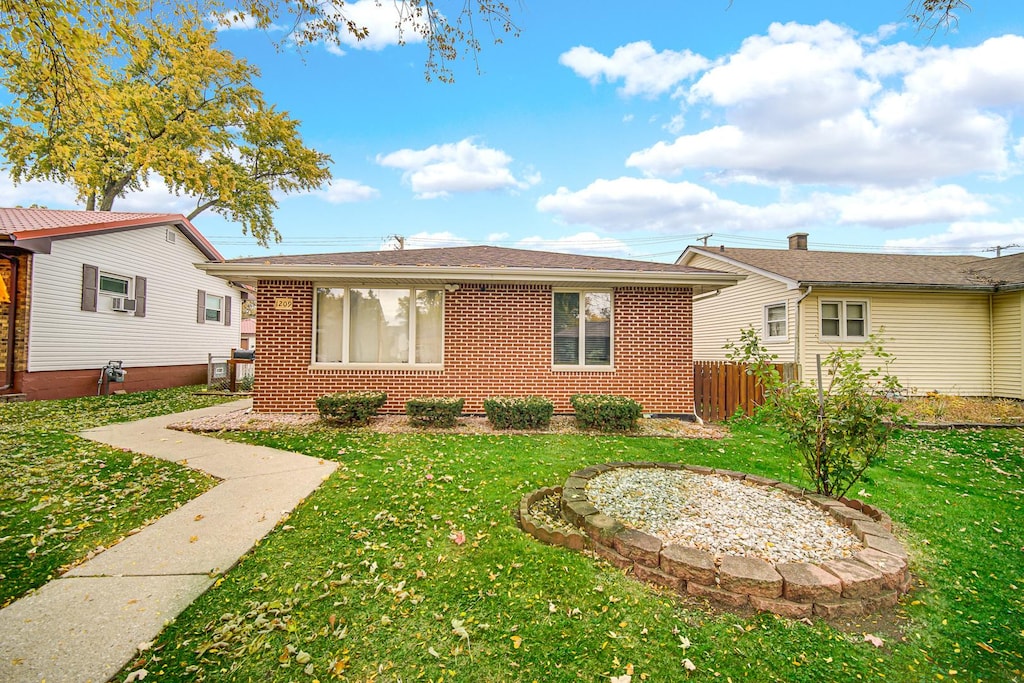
[199,246,741,415]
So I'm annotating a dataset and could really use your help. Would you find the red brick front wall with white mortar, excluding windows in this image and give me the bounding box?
[254,281,693,415]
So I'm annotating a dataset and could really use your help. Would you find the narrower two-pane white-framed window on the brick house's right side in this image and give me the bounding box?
[552,292,612,368]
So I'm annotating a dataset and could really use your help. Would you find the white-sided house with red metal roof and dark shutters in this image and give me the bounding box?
[0,209,242,398]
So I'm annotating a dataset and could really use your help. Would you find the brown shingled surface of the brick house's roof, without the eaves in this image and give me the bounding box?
[228,246,709,272]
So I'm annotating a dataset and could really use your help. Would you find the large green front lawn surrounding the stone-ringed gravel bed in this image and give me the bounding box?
[114,422,1024,682]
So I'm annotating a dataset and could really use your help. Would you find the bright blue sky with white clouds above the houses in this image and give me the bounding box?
[0,0,1024,261]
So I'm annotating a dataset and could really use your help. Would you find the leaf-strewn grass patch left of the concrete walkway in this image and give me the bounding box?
[0,387,234,605]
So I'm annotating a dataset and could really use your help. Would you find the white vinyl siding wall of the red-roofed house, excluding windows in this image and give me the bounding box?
[28,226,242,372]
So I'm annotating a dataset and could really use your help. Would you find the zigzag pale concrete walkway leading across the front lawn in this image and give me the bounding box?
[0,401,337,683]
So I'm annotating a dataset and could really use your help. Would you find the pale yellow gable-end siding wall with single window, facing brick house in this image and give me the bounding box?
[687,254,801,362]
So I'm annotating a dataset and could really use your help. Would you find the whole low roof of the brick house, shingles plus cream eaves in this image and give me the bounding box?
[200,246,743,291]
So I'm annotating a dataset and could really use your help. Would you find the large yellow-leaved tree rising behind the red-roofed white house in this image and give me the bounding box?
[0,9,330,244]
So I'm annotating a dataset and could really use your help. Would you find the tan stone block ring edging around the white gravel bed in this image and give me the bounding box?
[518,462,910,618]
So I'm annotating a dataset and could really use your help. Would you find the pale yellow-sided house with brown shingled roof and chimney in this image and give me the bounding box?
[677,232,1024,398]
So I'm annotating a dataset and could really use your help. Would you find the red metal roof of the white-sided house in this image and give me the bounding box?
[0,208,224,261]
